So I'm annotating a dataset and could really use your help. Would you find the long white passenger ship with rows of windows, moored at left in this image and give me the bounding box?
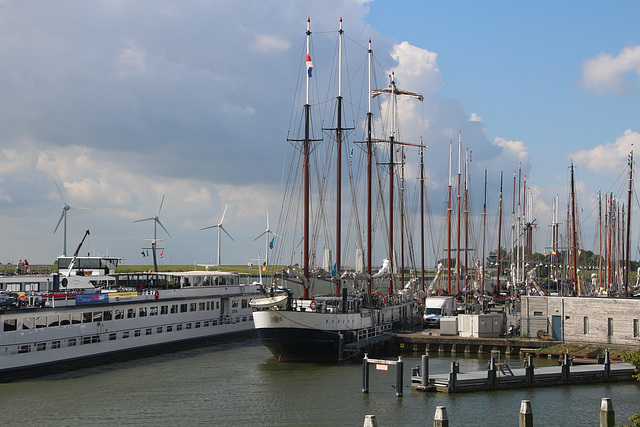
[0,257,261,381]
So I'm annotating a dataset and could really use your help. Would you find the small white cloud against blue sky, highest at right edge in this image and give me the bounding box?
[582,46,640,94]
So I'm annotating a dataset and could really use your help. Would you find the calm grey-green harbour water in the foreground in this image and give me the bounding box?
[0,340,640,427]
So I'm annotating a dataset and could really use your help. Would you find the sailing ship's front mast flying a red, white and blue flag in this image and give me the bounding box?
[302,18,312,299]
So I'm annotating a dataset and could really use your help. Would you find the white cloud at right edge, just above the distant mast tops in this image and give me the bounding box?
[571,129,640,173]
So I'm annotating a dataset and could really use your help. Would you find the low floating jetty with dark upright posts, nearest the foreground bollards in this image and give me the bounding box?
[411,350,635,393]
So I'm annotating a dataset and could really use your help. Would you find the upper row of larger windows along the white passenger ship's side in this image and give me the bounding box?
[3,299,249,332]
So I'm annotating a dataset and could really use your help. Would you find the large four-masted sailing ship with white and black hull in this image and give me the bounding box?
[251,20,422,362]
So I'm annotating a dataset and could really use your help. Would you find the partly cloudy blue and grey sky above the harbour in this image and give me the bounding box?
[0,0,640,265]
